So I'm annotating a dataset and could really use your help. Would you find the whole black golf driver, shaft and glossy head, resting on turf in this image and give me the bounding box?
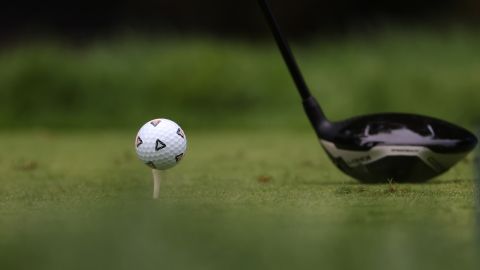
[258,0,478,183]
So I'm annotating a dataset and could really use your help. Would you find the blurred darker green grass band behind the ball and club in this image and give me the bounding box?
[0,30,480,129]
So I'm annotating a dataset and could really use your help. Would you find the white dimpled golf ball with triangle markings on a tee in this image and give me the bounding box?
[135,119,187,170]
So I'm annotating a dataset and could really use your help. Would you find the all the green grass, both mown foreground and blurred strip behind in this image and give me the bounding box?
[0,30,480,270]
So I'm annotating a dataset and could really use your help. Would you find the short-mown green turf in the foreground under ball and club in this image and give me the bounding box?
[0,130,479,269]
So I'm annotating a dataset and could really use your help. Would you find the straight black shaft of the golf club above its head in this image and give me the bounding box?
[258,0,312,100]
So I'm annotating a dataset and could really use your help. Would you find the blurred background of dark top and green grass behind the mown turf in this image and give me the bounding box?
[0,0,480,130]
